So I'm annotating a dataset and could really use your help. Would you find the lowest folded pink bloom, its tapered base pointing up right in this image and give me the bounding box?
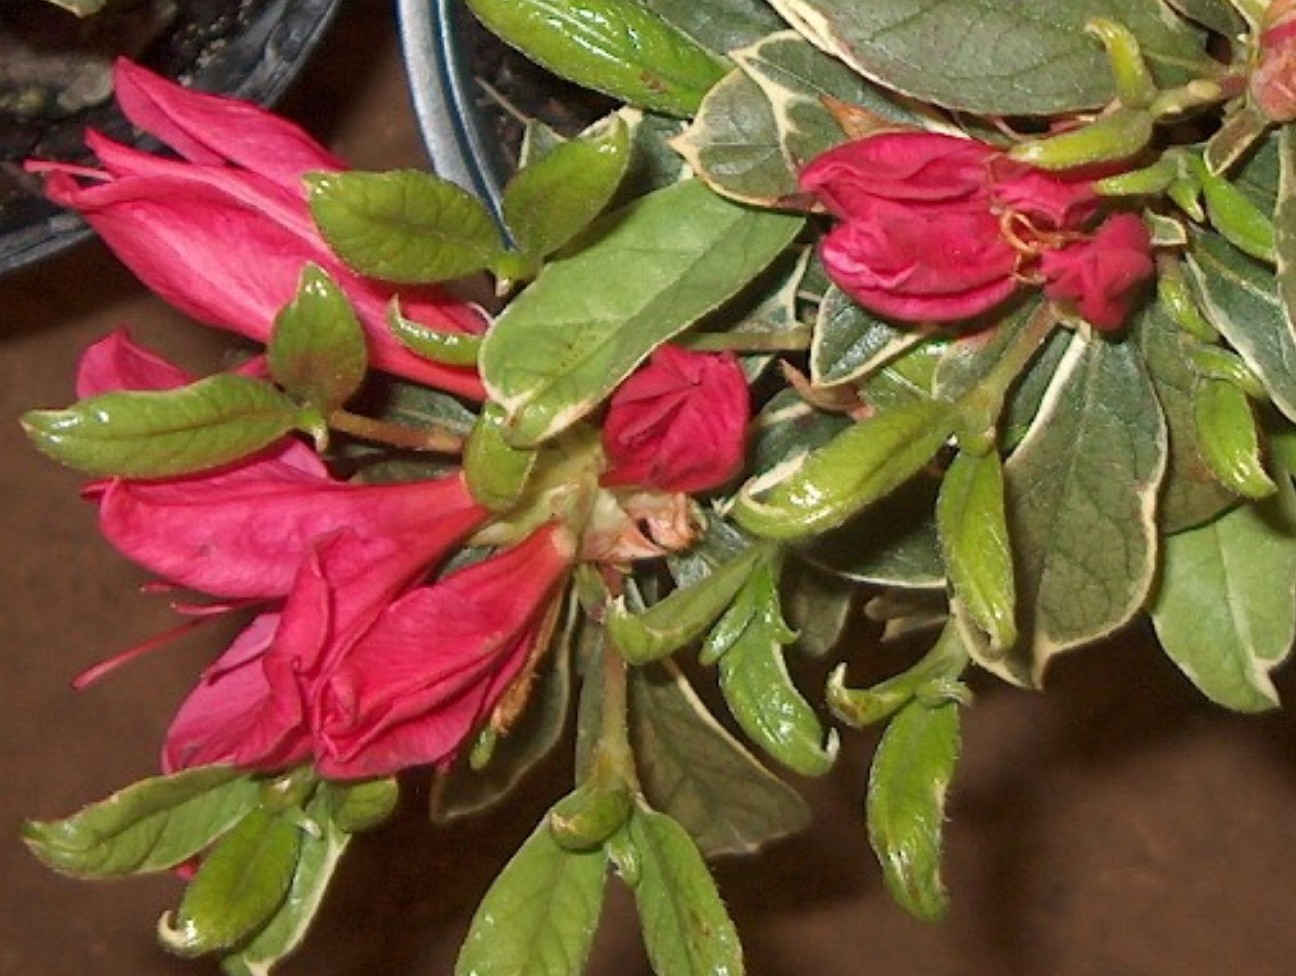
[163,524,574,779]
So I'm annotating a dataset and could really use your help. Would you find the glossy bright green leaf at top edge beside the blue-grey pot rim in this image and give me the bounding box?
[468,0,724,117]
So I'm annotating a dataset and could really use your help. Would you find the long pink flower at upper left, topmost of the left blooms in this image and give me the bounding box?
[29,61,485,399]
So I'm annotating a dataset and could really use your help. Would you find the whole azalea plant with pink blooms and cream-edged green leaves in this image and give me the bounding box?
[15,0,1296,976]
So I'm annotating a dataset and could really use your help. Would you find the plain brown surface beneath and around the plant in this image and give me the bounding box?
[0,0,1296,976]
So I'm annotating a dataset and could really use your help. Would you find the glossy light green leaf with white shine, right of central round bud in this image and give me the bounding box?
[734,399,956,539]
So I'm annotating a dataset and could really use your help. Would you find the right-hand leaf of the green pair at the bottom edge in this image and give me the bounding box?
[630,808,745,976]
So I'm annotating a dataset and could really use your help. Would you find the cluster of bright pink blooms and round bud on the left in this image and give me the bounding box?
[32,62,748,779]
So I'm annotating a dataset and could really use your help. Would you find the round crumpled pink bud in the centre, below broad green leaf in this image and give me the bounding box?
[603,345,750,493]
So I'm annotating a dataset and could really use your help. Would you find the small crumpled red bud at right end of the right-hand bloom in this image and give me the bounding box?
[1039,214,1156,329]
